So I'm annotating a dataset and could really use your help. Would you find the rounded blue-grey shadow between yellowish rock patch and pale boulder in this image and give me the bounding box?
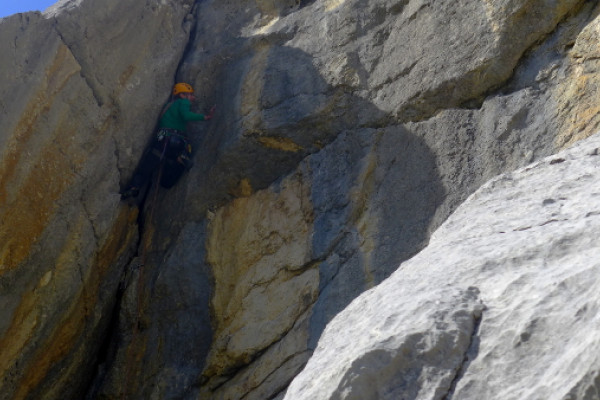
[309,122,445,349]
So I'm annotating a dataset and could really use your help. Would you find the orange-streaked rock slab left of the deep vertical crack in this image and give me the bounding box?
[0,1,190,399]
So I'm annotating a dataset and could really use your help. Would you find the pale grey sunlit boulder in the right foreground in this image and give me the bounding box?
[285,135,600,400]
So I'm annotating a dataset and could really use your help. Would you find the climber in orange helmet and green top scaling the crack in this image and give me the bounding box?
[121,83,215,199]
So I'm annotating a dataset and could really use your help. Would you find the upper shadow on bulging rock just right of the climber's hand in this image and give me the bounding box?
[187,38,384,209]
